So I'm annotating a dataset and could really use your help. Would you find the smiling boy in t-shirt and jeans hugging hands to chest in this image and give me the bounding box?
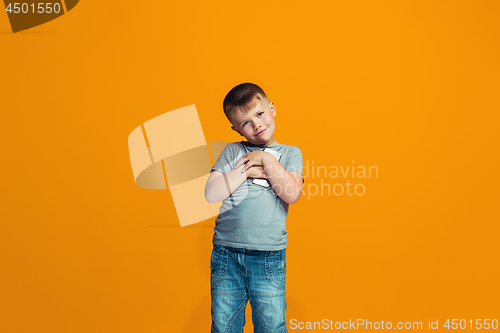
[205,83,304,333]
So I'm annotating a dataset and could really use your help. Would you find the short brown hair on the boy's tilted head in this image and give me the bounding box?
[222,82,269,121]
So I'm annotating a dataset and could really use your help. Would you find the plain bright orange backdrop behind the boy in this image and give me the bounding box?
[0,0,500,333]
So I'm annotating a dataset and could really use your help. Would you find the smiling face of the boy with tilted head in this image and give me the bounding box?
[231,100,276,145]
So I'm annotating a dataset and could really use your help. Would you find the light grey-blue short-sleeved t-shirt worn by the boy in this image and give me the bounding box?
[210,141,303,251]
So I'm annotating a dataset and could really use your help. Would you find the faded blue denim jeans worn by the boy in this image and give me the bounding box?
[210,245,288,333]
